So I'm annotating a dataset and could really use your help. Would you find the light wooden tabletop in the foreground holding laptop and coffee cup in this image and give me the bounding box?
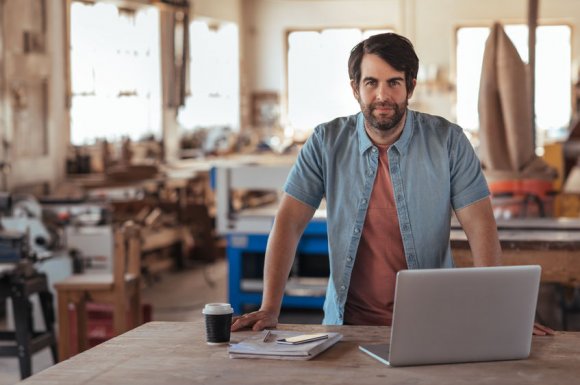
[15,319,580,385]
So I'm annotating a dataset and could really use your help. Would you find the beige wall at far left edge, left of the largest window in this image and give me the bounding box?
[0,0,68,190]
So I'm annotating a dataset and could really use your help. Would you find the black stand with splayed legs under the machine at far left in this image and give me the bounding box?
[0,272,57,379]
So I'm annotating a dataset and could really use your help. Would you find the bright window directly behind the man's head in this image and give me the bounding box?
[286,28,388,136]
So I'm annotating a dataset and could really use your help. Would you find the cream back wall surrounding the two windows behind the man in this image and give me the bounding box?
[242,0,580,120]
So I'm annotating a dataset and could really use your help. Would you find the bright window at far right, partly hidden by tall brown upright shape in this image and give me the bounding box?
[457,25,572,143]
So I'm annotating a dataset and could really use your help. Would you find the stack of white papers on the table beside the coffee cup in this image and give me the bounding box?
[228,330,342,360]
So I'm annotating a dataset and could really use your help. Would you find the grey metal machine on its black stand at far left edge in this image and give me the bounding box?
[0,193,58,378]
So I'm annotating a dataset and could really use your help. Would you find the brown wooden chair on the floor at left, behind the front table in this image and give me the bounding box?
[54,224,141,361]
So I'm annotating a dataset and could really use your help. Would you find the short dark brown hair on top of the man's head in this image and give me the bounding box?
[348,33,419,92]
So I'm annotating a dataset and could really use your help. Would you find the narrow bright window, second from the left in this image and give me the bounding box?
[177,20,240,131]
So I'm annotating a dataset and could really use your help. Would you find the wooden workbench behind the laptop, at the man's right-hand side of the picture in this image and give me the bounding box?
[451,218,580,286]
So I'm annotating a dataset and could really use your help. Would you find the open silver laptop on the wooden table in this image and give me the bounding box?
[359,265,541,366]
